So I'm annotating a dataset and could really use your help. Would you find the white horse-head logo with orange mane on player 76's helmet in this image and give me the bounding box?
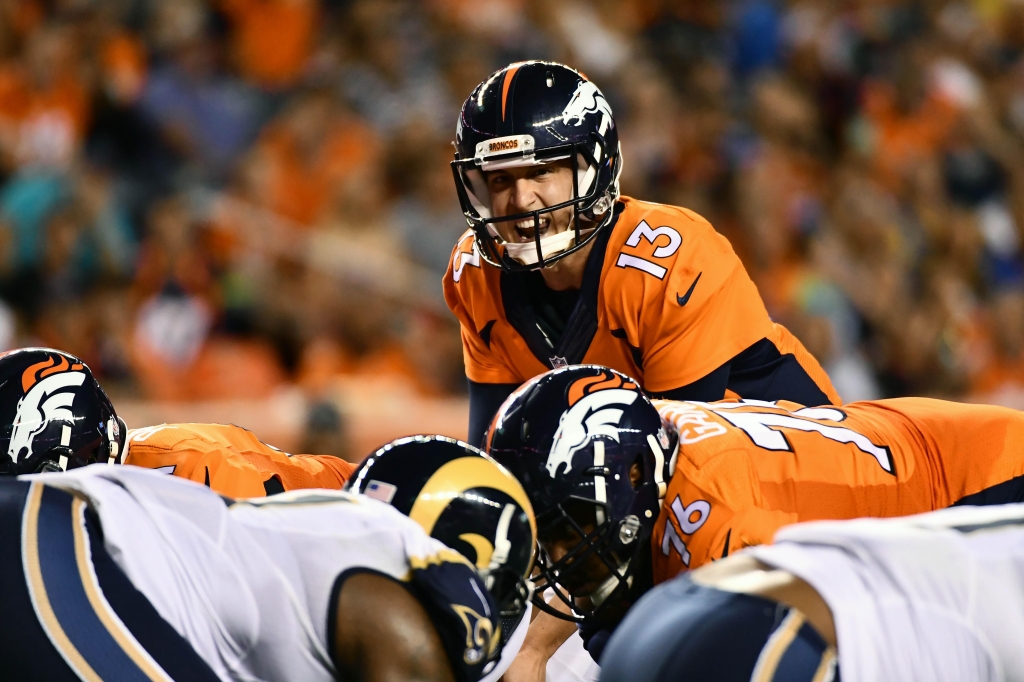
[547,372,640,478]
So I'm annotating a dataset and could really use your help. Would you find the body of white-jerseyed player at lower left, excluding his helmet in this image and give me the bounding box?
[0,466,501,682]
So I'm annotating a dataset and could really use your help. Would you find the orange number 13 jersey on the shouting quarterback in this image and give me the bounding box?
[444,197,839,403]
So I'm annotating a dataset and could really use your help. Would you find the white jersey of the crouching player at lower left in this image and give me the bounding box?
[29,465,493,682]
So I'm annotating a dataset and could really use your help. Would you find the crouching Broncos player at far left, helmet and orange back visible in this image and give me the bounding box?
[0,348,355,491]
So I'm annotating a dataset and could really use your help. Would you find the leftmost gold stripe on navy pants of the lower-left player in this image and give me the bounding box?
[22,483,103,682]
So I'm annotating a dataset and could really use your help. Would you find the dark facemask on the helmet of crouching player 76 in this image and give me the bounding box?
[534,496,635,623]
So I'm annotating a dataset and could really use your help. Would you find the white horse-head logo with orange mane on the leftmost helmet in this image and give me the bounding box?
[7,355,85,463]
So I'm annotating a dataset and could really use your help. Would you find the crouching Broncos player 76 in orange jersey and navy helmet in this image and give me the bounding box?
[487,366,1024,659]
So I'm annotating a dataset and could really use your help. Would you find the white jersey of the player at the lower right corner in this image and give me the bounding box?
[744,505,1024,682]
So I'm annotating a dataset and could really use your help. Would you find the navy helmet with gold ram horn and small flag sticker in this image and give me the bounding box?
[345,435,537,640]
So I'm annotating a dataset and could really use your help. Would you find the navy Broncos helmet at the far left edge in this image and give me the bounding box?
[0,348,127,475]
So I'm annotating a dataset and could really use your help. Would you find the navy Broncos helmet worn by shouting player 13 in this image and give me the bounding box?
[452,61,623,271]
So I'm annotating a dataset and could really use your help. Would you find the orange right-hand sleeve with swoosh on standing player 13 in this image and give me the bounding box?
[624,219,773,392]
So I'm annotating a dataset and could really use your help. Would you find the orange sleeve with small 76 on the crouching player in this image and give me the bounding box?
[651,450,797,584]
